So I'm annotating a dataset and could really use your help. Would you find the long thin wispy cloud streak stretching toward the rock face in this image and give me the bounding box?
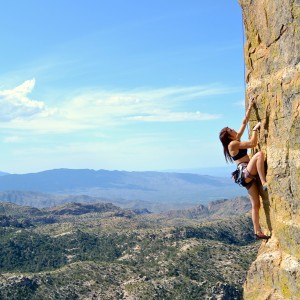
[64,86,227,124]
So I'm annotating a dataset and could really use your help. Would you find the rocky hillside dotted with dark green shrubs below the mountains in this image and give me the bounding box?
[0,200,259,300]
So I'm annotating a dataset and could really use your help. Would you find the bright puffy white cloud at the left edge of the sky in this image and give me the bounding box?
[0,79,46,121]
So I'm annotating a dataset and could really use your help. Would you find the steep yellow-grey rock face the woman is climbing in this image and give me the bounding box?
[239,0,300,300]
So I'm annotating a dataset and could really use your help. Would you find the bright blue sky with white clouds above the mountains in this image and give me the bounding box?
[0,0,248,173]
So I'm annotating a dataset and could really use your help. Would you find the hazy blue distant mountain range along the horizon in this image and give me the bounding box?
[0,169,245,208]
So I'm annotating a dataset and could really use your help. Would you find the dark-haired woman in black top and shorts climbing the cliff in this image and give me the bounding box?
[220,100,270,239]
